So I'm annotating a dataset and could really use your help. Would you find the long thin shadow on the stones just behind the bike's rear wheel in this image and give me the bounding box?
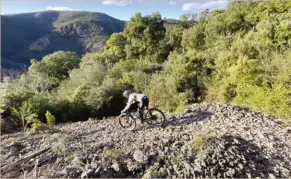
[164,110,213,127]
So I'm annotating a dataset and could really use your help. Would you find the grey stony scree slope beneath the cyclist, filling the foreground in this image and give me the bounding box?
[1,103,291,178]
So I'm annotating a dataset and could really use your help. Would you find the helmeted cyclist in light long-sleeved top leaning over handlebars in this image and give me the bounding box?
[121,90,149,117]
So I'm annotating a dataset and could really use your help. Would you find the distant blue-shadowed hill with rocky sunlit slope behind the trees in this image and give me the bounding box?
[1,11,125,68]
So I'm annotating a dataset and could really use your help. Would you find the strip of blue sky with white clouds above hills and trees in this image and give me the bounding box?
[1,0,228,20]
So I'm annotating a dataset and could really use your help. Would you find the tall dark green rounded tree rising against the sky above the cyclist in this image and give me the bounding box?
[124,13,168,62]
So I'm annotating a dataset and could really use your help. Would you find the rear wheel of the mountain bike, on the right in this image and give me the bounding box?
[145,108,166,126]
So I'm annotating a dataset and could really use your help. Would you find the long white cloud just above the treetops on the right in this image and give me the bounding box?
[182,0,228,11]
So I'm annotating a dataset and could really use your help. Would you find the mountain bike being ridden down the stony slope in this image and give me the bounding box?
[118,108,166,130]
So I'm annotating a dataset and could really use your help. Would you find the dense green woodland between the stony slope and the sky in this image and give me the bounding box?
[0,0,291,127]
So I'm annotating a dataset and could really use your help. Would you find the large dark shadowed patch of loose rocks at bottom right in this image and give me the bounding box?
[193,136,280,178]
